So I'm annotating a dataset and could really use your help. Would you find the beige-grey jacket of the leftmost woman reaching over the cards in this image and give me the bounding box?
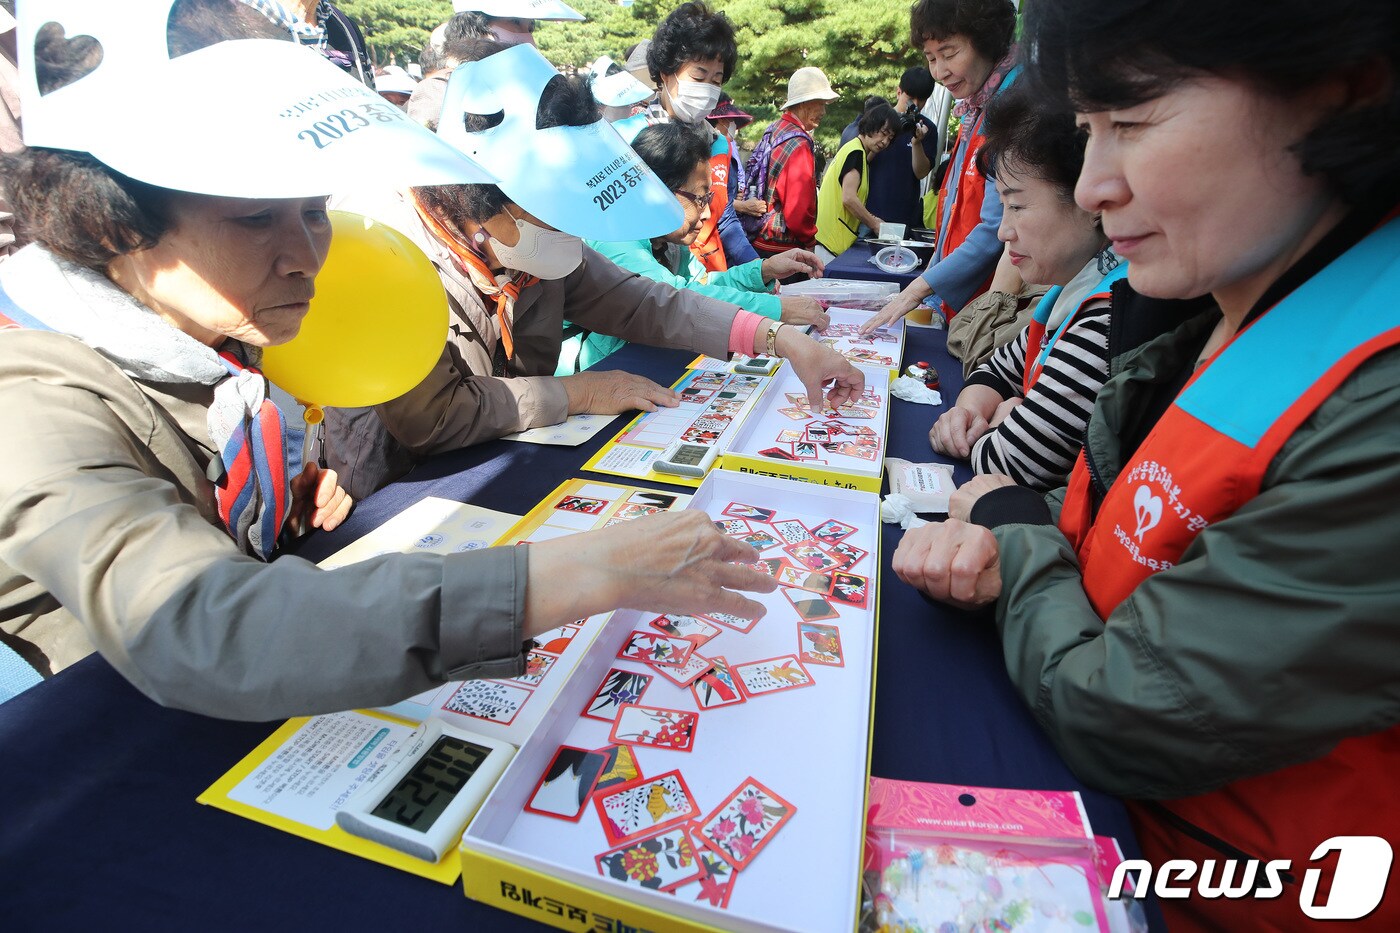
[0,319,528,720]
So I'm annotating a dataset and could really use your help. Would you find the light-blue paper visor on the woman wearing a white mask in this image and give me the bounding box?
[438,45,685,240]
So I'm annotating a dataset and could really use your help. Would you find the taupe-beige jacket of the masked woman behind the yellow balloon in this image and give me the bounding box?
[326,184,739,497]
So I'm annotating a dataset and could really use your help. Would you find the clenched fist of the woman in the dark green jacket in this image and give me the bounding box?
[892,518,1001,609]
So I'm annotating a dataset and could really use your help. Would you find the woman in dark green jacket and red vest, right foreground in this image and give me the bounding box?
[893,0,1400,930]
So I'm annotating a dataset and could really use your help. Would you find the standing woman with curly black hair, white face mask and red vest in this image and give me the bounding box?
[613,3,759,272]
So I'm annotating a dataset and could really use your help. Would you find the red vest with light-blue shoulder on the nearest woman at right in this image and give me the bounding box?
[1060,221,1400,930]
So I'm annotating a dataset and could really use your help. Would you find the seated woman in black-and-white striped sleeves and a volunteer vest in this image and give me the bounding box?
[928,87,1127,493]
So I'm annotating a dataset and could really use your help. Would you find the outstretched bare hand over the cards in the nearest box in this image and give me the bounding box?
[525,510,777,636]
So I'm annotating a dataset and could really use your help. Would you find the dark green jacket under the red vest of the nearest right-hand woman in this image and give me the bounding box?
[994,312,1400,799]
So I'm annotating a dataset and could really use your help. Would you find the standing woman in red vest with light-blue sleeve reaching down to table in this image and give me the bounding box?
[862,0,1016,332]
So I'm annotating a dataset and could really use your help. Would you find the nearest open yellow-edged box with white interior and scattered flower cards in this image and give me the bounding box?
[461,471,881,933]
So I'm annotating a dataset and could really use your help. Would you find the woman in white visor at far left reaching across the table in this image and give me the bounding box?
[0,0,776,720]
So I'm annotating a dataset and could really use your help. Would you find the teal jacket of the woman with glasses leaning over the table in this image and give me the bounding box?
[554,240,783,375]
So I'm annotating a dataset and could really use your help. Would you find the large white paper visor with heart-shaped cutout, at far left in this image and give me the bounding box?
[17,0,496,198]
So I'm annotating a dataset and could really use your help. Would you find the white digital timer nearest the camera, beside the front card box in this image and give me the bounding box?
[336,719,515,862]
